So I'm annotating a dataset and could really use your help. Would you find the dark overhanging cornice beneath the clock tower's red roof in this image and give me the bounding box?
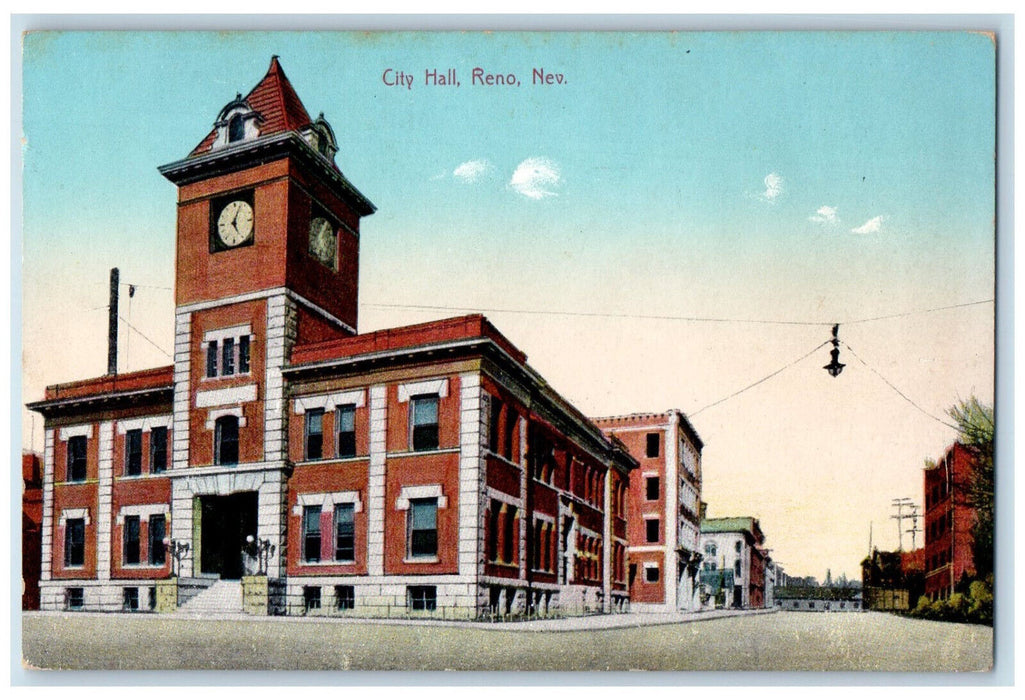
[157,131,377,216]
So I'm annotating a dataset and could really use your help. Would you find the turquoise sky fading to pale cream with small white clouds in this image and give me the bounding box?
[15,32,995,580]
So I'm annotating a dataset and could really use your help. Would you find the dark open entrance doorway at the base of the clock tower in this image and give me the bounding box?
[200,491,256,579]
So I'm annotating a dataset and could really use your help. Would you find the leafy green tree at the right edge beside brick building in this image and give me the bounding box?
[947,397,995,579]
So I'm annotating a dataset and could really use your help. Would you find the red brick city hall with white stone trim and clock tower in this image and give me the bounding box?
[30,57,639,618]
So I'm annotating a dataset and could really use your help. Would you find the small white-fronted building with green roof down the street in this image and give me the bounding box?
[701,517,766,608]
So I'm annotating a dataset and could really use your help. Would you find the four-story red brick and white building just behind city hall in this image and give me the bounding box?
[595,409,703,612]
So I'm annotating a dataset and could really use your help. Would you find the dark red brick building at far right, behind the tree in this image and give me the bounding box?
[924,443,975,601]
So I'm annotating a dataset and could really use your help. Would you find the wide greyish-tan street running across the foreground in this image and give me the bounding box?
[23,613,993,671]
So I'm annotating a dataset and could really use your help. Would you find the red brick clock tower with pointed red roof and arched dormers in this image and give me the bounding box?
[160,56,374,577]
